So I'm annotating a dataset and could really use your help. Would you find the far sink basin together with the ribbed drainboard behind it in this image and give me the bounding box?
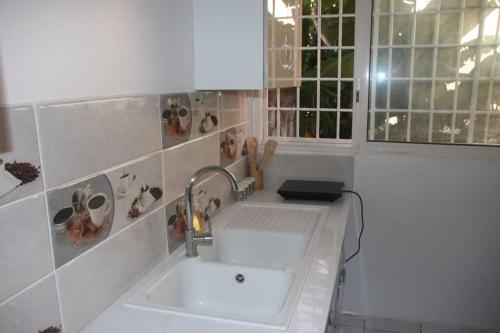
[198,204,321,268]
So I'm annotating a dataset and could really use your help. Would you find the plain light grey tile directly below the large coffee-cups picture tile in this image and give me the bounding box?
[56,209,166,333]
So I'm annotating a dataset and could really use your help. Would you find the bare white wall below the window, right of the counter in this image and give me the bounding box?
[343,152,500,329]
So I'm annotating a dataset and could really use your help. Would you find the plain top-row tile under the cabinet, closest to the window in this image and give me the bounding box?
[219,91,248,129]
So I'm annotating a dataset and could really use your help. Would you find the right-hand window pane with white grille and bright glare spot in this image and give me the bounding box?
[368,0,500,145]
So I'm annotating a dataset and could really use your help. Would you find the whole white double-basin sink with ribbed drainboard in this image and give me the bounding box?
[124,203,328,330]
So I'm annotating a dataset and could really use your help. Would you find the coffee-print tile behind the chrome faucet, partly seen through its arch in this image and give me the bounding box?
[165,176,222,254]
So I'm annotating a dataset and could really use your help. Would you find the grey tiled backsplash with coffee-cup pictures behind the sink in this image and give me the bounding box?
[0,91,248,332]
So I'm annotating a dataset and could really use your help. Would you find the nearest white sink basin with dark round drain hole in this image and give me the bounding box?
[142,259,294,318]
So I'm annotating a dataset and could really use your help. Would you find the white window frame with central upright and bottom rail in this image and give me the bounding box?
[256,0,500,161]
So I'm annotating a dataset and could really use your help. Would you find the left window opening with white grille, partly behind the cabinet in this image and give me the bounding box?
[265,0,355,143]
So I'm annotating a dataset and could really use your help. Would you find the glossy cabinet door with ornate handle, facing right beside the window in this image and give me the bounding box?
[266,0,302,88]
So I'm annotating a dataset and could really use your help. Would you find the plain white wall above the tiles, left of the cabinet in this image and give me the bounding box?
[0,0,193,104]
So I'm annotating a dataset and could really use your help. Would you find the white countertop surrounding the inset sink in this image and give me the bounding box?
[82,189,351,333]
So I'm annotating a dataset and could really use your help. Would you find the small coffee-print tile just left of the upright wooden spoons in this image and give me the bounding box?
[220,125,248,167]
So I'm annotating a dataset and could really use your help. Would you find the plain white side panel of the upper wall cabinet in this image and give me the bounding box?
[193,0,265,90]
